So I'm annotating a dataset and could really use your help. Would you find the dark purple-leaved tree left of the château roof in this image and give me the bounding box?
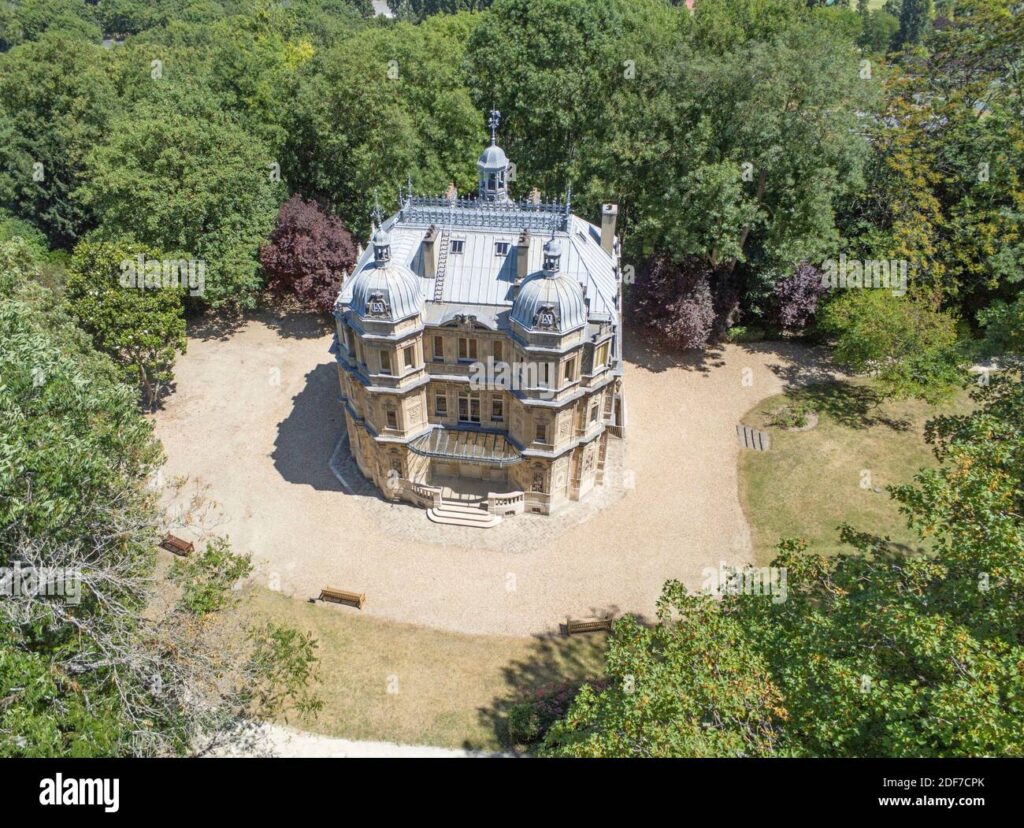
[260,195,355,313]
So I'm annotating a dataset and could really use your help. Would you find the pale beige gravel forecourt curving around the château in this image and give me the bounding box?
[155,316,827,636]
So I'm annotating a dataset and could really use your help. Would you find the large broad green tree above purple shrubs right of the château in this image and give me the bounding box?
[594,0,878,336]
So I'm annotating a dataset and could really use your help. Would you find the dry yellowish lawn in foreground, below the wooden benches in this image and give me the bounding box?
[245,587,605,750]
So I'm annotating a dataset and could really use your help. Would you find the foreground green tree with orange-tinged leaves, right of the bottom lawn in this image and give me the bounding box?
[541,581,787,757]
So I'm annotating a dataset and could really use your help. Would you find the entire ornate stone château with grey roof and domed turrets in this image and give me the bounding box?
[334,123,625,515]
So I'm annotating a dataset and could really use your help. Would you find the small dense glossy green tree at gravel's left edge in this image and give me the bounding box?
[67,241,187,410]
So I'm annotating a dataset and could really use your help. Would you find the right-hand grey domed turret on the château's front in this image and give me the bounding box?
[511,238,587,334]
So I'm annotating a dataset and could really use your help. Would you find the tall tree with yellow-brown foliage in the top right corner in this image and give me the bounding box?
[845,0,1024,321]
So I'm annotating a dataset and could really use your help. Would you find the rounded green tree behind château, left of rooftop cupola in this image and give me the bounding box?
[282,14,485,232]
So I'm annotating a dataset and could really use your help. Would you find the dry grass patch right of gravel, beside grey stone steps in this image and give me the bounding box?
[739,381,971,564]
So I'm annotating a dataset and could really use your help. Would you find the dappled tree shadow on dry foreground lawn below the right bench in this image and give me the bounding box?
[464,607,653,750]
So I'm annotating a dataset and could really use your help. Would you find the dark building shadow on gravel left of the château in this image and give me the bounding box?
[271,362,345,491]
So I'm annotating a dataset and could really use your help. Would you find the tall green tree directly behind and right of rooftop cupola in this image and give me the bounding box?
[467,0,688,198]
